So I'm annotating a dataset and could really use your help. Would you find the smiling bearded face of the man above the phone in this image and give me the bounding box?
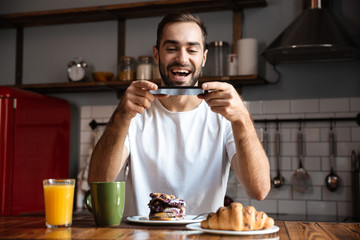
[153,19,207,86]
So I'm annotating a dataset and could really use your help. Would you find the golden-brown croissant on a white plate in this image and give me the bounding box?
[201,202,274,231]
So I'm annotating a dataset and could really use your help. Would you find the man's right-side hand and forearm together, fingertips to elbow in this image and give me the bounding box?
[199,82,270,200]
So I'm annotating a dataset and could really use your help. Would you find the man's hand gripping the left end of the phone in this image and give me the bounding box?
[117,80,167,120]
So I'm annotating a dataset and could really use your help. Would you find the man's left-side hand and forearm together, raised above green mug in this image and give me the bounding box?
[88,80,168,183]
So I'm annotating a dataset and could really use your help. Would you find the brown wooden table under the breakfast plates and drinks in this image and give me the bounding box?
[0,216,360,240]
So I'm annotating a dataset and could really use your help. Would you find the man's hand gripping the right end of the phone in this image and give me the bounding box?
[199,82,248,122]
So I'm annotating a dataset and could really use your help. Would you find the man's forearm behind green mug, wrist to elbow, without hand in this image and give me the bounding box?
[88,112,130,183]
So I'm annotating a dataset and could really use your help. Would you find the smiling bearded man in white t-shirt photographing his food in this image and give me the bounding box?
[88,13,270,216]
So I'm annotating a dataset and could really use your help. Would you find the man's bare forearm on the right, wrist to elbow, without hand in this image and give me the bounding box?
[231,116,270,200]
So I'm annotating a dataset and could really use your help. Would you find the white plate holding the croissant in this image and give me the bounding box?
[186,223,280,235]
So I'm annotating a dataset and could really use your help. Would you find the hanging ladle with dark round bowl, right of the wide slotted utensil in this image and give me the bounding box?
[325,121,341,192]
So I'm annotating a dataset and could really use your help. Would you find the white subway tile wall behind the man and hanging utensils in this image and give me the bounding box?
[80,97,360,217]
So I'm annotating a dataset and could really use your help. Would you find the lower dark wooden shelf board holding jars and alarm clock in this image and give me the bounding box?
[11,75,266,93]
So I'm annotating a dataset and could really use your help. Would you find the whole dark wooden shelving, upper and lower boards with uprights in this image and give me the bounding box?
[0,0,267,93]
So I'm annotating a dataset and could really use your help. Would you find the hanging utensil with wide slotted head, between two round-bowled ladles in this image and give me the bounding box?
[291,121,309,193]
